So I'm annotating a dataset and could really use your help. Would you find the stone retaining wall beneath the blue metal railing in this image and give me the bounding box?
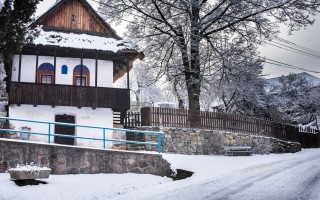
[0,139,171,176]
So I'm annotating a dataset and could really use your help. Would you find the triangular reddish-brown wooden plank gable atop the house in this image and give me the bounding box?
[33,0,120,39]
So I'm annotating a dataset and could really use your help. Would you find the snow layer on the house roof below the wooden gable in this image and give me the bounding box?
[31,29,140,52]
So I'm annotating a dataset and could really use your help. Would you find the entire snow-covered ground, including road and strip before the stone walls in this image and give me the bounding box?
[0,149,320,200]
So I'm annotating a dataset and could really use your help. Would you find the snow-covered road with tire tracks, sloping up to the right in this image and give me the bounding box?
[151,155,320,200]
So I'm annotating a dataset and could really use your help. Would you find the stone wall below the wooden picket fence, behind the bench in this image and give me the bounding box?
[139,127,301,155]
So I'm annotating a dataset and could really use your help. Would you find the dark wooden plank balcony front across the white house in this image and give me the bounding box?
[9,82,130,111]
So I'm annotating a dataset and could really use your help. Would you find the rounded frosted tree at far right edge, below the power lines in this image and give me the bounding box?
[269,74,320,124]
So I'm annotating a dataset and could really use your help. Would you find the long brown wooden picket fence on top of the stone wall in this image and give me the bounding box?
[141,107,298,141]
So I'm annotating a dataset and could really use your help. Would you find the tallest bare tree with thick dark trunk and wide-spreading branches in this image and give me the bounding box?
[100,0,320,110]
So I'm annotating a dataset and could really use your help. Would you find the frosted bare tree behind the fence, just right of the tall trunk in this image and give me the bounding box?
[200,38,265,116]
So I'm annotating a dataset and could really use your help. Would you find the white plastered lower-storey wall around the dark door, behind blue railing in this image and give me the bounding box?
[9,105,113,148]
